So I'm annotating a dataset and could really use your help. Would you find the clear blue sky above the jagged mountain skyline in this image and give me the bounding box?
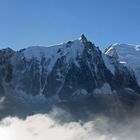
[0,0,140,50]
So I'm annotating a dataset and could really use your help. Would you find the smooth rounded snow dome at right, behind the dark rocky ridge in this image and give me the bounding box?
[105,43,140,85]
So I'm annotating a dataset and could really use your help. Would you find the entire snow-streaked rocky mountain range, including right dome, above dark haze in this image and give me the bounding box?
[0,35,140,105]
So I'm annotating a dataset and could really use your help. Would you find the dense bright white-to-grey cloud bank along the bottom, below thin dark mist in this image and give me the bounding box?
[0,114,140,140]
